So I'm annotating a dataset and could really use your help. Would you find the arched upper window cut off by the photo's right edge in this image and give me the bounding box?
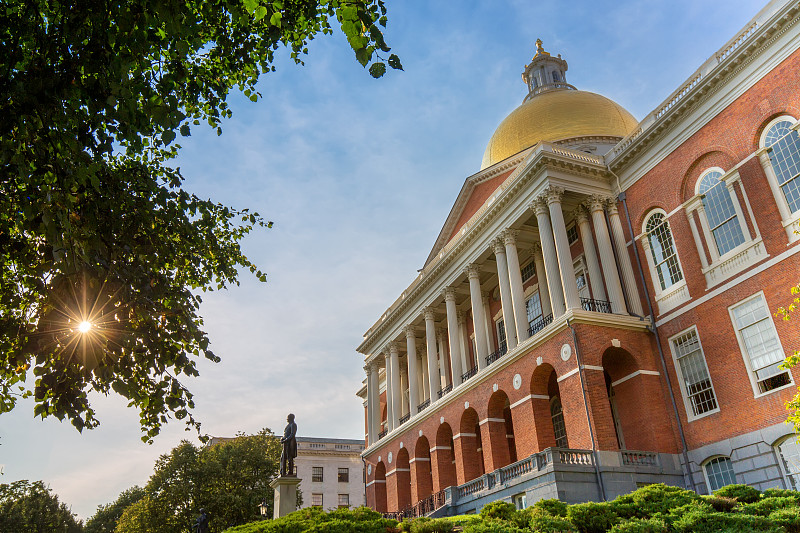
[764,118,800,214]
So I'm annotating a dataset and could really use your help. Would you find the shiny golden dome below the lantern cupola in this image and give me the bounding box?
[481,89,639,170]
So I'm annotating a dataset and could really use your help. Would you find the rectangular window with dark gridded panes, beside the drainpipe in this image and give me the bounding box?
[670,328,718,418]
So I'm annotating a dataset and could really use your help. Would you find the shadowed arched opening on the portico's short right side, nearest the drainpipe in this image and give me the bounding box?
[595,348,666,450]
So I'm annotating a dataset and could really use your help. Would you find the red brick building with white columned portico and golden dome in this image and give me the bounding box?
[358,0,800,514]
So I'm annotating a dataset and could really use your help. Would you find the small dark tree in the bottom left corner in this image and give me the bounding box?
[0,480,83,533]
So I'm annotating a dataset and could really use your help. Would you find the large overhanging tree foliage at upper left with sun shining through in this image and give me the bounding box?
[0,0,402,441]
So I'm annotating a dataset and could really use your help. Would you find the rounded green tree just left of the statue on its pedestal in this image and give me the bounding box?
[114,429,281,533]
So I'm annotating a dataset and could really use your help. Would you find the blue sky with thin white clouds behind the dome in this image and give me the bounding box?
[0,0,763,518]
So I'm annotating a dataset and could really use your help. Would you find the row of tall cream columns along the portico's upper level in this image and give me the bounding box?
[364,186,643,444]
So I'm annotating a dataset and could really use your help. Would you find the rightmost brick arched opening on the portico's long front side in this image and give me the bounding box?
[531,364,569,451]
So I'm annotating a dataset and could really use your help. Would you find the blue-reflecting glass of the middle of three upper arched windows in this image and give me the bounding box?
[697,169,744,255]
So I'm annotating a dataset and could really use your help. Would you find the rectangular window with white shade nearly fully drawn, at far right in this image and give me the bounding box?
[731,294,791,394]
